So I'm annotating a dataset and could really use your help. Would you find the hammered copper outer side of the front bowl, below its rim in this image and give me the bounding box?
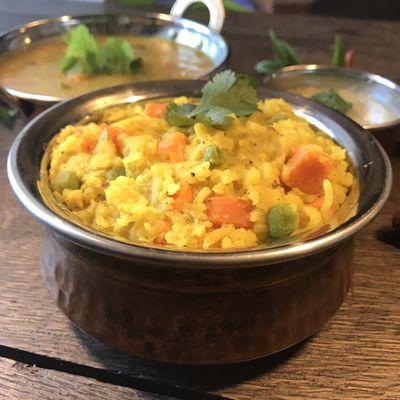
[42,229,353,364]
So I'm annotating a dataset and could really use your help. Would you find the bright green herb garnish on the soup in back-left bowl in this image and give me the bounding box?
[60,25,140,75]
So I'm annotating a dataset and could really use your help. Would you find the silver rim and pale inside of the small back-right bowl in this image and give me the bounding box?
[265,64,400,131]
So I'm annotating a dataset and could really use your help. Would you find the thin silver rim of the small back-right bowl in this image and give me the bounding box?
[264,64,400,131]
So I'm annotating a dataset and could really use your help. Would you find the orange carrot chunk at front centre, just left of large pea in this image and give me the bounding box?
[206,196,253,229]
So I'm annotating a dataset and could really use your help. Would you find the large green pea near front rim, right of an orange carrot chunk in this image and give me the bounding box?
[267,204,299,239]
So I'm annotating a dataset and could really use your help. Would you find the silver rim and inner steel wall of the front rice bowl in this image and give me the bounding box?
[8,80,392,265]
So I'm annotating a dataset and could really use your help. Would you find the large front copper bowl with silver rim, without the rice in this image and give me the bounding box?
[8,81,392,364]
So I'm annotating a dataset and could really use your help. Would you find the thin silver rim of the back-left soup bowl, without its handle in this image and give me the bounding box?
[0,10,229,105]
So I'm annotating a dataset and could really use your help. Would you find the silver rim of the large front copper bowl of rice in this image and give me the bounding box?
[7,80,393,268]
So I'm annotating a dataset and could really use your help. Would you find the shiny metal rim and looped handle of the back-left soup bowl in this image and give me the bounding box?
[0,0,228,106]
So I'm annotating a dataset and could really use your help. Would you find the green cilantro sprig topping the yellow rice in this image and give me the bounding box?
[165,70,258,127]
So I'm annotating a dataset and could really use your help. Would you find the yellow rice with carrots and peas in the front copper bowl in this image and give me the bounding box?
[39,97,353,249]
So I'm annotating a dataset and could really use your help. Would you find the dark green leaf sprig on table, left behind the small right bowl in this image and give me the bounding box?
[255,30,301,74]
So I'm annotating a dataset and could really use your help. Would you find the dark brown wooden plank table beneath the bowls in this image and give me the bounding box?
[0,0,400,400]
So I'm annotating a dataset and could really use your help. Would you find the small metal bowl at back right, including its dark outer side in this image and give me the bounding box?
[264,64,400,154]
